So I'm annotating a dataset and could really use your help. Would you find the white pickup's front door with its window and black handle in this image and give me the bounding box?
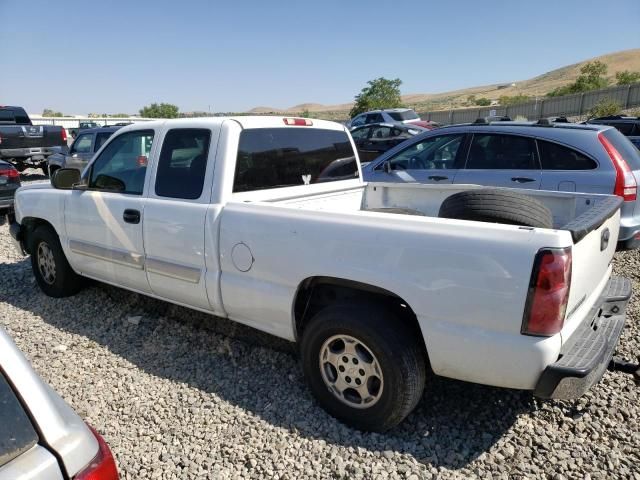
[65,129,156,292]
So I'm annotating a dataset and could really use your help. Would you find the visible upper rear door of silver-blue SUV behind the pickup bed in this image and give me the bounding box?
[455,132,542,190]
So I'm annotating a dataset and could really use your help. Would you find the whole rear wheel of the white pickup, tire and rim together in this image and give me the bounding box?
[301,303,426,432]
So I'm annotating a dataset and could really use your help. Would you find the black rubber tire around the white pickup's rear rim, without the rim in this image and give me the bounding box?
[300,303,426,432]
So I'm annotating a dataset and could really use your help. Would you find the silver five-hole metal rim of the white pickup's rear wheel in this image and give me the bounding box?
[320,335,384,408]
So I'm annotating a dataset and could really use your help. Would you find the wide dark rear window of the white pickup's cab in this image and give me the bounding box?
[233,128,358,192]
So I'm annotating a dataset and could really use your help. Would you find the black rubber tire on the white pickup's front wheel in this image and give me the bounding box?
[29,226,81,298]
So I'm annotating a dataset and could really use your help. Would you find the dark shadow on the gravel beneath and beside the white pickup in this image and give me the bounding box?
[0,260,534,468]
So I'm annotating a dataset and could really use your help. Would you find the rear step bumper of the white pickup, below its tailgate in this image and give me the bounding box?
[534,277,631,399]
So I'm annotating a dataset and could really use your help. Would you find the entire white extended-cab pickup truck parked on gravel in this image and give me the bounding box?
[10,117,631,431]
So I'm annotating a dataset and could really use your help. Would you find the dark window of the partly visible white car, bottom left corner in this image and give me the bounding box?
[0,371,38,467]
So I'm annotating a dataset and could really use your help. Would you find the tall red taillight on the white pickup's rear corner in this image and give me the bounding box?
[521,248,571,336]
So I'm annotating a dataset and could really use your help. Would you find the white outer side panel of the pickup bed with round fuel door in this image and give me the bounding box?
[220,203,571,388]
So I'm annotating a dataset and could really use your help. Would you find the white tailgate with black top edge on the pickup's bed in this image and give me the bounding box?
[562,196,622,328]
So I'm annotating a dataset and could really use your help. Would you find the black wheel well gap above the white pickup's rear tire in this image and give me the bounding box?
[294,277,427,355]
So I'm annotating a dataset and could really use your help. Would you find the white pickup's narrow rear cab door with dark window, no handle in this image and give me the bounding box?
[143,120,221,313]
